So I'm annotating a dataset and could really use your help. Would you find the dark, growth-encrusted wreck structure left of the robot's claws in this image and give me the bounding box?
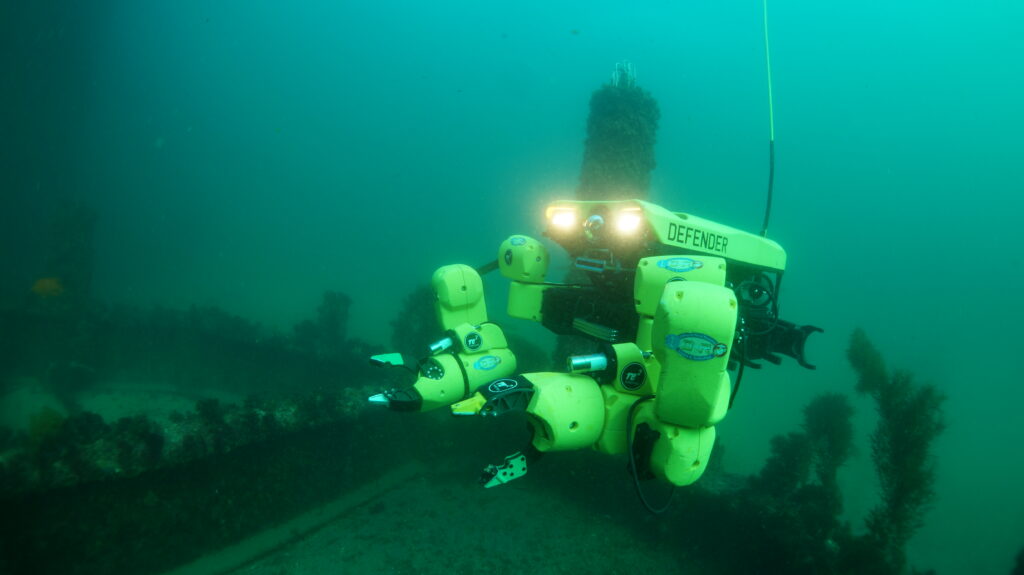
[0,293,401,573]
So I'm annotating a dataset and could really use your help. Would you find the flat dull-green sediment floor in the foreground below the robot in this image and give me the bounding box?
[205,454,699,575]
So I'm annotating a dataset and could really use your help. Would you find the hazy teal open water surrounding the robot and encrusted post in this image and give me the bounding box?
[0,0,1024,574]
